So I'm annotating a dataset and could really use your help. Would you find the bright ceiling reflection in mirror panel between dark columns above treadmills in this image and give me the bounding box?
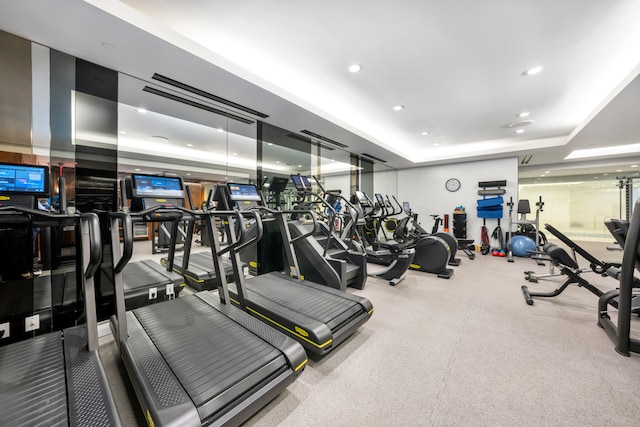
[118,75,256,264]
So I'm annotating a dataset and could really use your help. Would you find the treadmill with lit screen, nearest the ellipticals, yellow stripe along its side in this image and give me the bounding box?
[216,183,373,356]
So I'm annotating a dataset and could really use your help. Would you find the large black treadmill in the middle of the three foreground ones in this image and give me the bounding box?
[110,201,307,427]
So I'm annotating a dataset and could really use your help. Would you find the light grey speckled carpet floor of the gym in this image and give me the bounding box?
[100,243,640,426]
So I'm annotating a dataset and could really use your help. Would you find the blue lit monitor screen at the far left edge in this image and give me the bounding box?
[0,163,49,197]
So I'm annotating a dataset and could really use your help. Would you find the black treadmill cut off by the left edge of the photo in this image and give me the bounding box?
[0,205,121,426]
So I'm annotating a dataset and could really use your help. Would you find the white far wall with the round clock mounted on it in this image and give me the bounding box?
[398,157,518,244]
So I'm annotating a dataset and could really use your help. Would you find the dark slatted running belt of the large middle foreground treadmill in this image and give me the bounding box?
[133,295,287,419]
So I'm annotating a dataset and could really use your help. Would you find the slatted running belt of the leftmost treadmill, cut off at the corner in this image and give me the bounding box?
[0,332,69,426]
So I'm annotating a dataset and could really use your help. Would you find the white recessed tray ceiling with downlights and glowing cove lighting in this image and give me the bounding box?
[0,0,640,176]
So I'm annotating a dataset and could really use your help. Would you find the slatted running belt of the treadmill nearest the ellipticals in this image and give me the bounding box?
[239,273,363,330]
